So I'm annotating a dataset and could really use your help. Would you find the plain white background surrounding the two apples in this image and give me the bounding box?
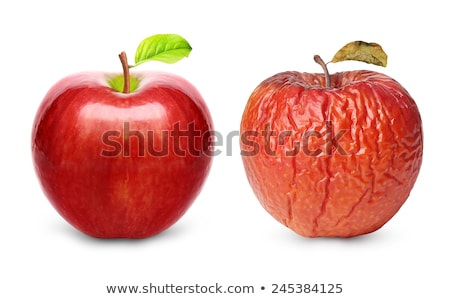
[0,0,450,298]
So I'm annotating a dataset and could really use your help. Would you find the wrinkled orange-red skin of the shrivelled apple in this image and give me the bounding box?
[240,71,423,237]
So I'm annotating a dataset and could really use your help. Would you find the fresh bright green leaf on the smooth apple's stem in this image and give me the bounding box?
[130,34,192,67]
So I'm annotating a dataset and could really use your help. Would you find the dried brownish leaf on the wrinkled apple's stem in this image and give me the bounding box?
[331,41,387,67]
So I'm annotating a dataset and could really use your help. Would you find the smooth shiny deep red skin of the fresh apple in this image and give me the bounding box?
[32,72,213,238]
